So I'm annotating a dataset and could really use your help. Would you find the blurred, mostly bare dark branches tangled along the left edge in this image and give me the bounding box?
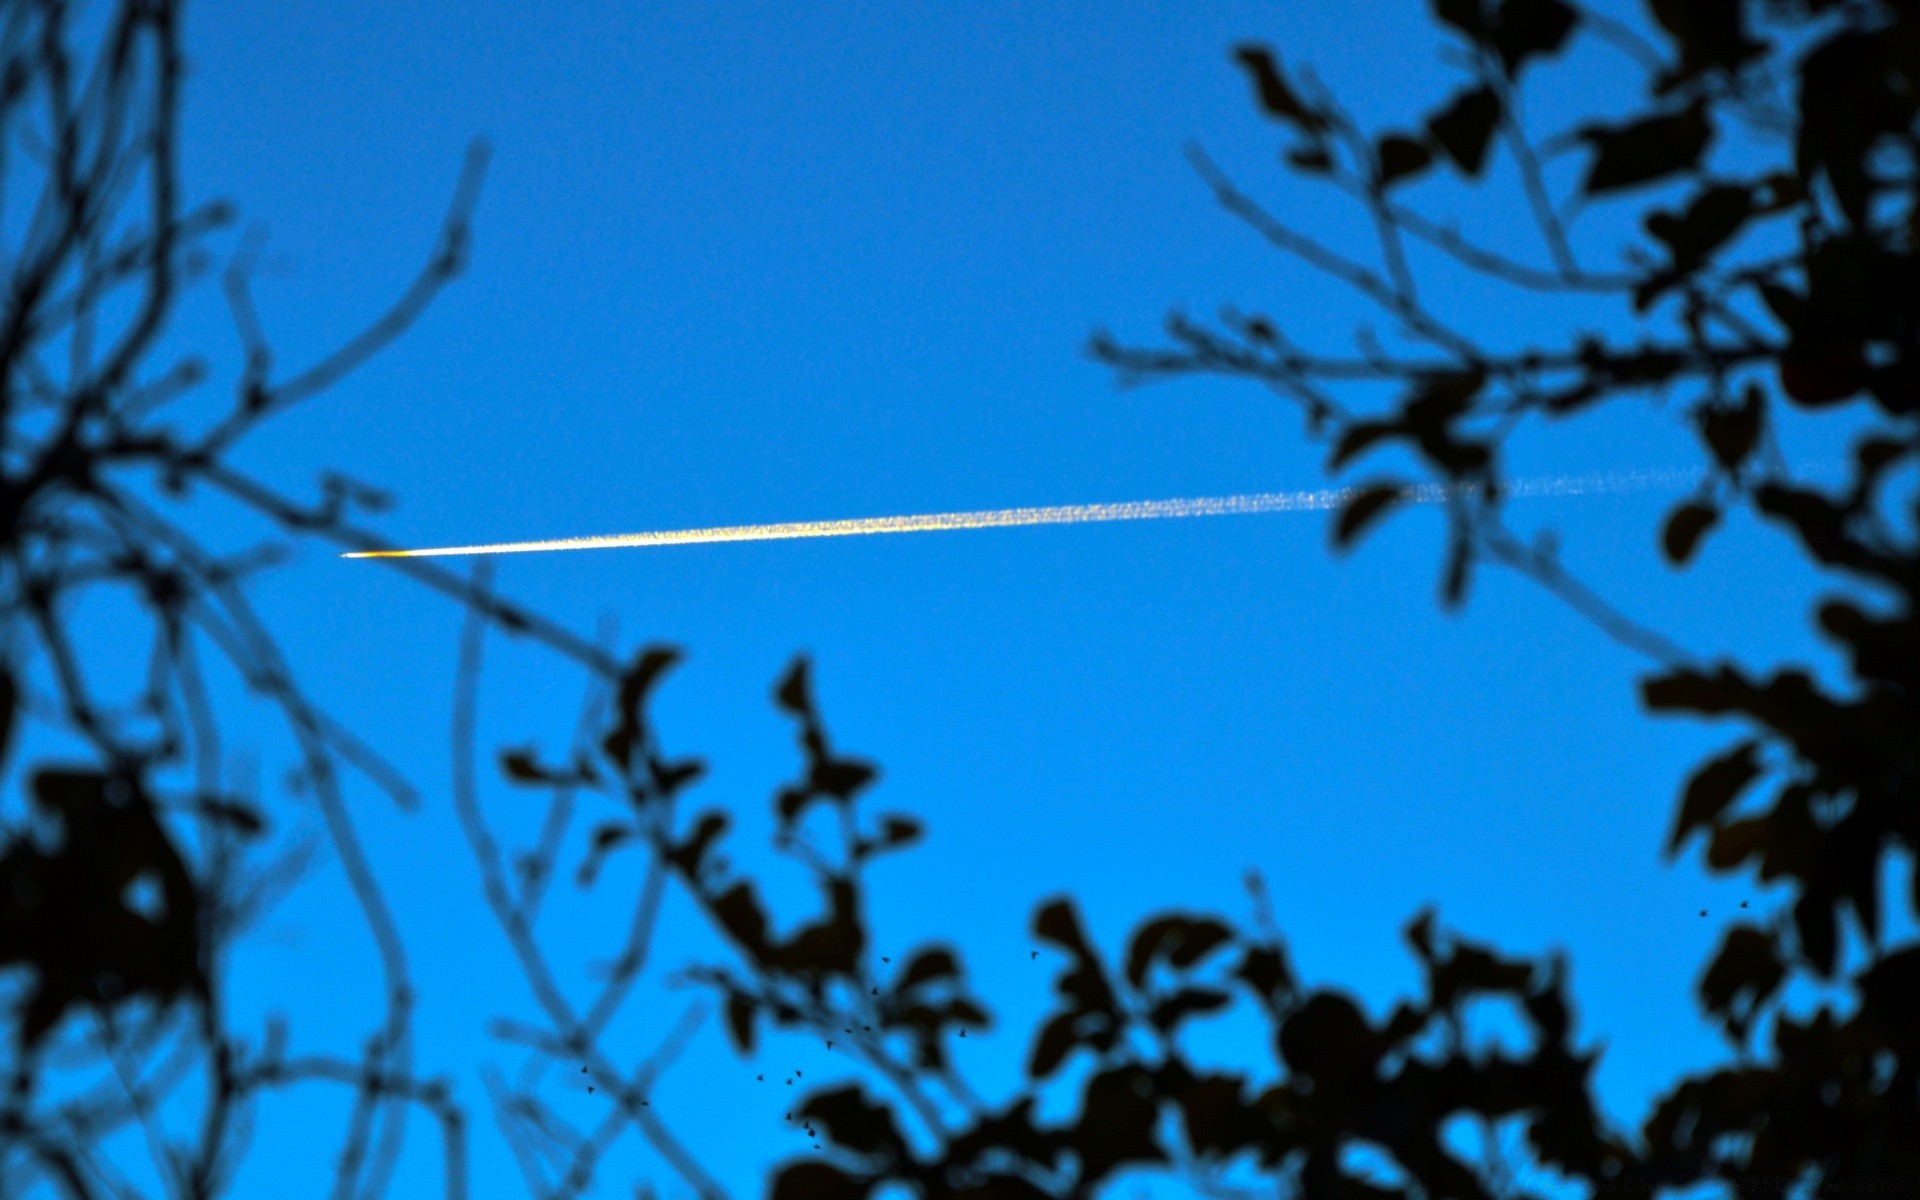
[0,0,599,1196]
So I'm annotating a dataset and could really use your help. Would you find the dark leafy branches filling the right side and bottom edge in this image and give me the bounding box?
[568,0,1920,1200]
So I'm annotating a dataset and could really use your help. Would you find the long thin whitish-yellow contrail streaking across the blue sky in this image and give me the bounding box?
[340,470,1699,559]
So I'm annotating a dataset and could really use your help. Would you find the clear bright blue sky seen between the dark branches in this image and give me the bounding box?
[116,0,1901,1196]
